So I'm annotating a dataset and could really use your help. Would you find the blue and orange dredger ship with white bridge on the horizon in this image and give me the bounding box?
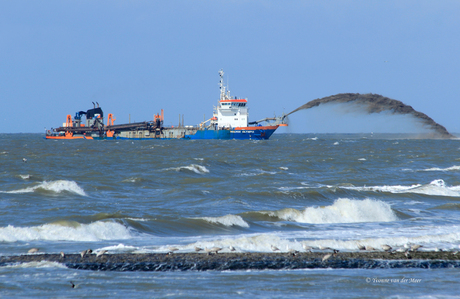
[45,70,287,140]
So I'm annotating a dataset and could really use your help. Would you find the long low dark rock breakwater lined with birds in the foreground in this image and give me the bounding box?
[0,251,460,271]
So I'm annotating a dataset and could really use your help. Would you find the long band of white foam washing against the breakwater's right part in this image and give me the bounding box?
[184,226,460,252]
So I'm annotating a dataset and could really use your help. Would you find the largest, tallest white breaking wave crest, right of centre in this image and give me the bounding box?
[267,198,398,223]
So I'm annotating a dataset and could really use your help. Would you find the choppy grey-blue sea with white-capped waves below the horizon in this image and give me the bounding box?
[0,134,460,299]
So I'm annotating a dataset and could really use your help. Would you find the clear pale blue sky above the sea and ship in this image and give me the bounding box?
[0,0,460,133]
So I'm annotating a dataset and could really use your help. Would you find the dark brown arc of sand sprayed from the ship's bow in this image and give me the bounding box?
[286,93,455,138]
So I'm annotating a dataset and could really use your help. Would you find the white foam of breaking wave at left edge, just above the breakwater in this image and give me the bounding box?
[0,221,132,242]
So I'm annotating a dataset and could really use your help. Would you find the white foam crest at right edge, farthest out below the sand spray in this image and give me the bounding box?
[342,180,460,197]
